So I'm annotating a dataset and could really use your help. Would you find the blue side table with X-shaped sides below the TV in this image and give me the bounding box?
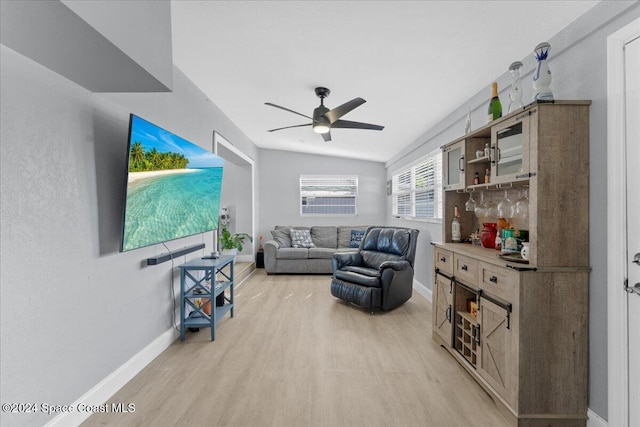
[179,255,235,341]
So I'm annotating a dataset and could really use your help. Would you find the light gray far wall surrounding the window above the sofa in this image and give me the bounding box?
[258,149,387,241]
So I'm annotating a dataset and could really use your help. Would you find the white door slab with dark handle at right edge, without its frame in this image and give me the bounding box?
[625,33,640,426]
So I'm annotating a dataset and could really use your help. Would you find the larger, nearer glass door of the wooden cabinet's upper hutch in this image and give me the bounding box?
[491,116,530,184]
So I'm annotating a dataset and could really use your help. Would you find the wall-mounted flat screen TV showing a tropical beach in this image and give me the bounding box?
[120,114,224,251]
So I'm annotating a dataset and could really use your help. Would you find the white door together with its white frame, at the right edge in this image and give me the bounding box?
[607,19,640,427]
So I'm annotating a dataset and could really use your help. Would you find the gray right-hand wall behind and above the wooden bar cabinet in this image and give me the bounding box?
[386,1,640,420]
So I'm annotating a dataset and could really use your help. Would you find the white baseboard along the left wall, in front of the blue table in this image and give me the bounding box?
[46,328,178,427]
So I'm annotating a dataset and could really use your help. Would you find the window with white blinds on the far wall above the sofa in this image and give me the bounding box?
[300,175,358,216]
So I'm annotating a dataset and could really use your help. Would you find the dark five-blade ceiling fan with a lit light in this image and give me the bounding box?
[265,87,384,141]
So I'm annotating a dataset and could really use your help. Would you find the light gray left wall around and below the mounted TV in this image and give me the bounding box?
[0,31,257,426]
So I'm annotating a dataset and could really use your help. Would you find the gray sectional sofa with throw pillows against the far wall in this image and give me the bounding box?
[264,225,367,274]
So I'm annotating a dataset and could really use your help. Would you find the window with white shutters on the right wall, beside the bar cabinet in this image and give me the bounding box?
[392,150,442,221]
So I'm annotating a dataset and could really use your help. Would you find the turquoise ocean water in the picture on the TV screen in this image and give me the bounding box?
[123,167,222,251]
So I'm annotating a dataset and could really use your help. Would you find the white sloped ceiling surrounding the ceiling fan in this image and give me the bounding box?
[171,0,598,162]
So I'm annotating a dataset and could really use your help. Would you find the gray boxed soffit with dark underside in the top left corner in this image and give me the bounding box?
[0,0,173,92]
